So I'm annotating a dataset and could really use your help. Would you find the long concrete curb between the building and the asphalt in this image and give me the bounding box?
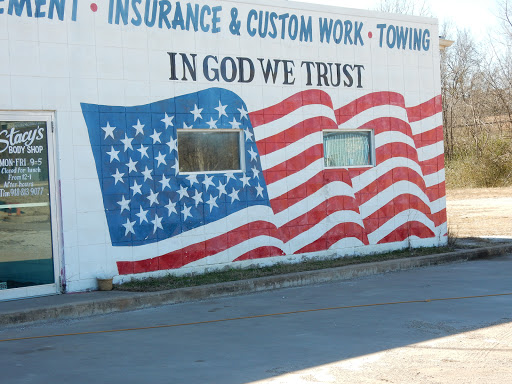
[0,244,512,326]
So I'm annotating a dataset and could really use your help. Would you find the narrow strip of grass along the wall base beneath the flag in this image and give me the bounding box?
[114,246,455,292]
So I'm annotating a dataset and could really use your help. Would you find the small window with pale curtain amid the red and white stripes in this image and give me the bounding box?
[324,131,373,168]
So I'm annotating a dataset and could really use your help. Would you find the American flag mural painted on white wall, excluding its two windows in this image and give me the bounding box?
[82,88,446,275]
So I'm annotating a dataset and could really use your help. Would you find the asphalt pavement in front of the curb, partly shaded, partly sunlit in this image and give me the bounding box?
[0,253,512,384]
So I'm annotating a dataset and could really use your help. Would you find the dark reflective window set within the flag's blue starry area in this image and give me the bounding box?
[178,129,243,172]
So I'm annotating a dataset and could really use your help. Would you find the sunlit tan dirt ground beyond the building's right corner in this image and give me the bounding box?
[446,188,512,239]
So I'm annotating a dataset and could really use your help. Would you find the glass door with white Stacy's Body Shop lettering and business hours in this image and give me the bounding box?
[0,112,58,300]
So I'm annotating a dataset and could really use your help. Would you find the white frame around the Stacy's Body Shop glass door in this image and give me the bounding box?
[0,110,62,301]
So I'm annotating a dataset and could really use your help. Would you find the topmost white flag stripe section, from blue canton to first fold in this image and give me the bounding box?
[253,104,336,141]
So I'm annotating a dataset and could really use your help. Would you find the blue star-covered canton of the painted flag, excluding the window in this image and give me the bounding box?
[82,88,270,246]
